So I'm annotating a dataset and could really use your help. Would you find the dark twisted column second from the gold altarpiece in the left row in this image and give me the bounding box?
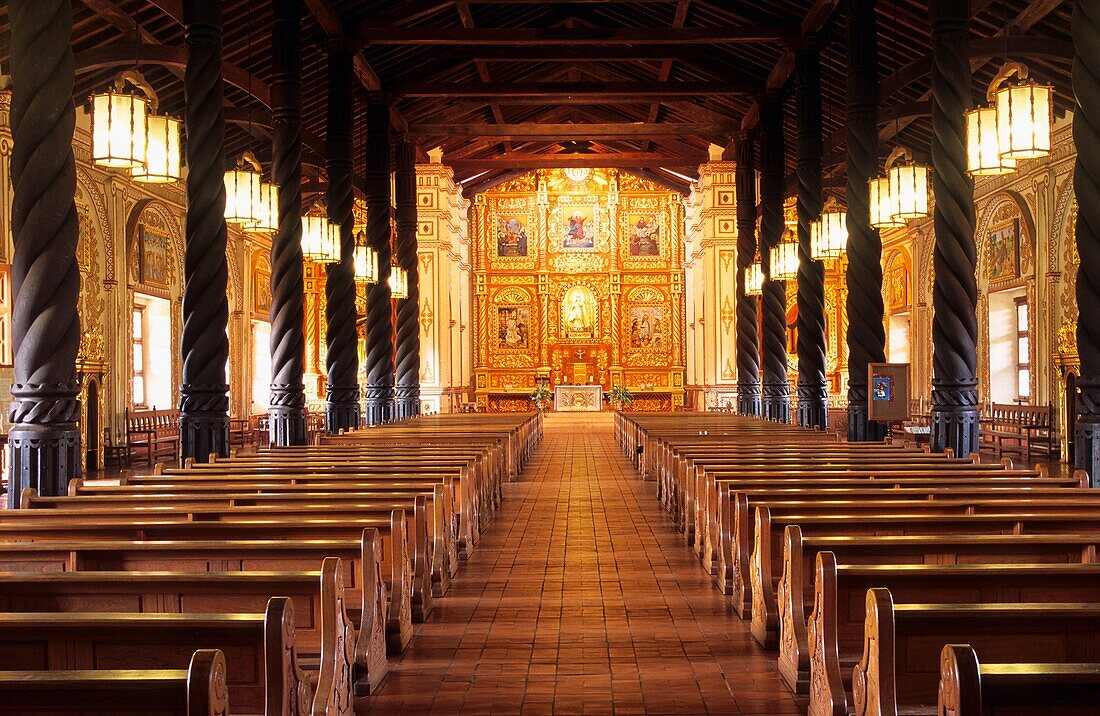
[363,97,394,426]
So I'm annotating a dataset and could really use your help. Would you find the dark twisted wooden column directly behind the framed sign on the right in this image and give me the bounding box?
[845,0,887,441]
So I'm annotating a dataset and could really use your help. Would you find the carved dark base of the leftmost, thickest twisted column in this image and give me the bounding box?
[8,423,84,509]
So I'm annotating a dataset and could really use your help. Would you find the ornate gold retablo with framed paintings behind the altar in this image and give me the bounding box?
[471,168,685,410]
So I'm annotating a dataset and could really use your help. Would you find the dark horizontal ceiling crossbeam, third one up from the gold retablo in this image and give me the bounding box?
[389,80,758,97]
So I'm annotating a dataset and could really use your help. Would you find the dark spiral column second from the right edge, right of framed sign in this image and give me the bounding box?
[928,0,978,456]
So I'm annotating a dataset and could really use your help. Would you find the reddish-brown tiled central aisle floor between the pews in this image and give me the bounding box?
[370,414,799,716]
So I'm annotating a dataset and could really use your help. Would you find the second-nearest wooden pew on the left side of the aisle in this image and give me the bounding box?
[0,597,312,714]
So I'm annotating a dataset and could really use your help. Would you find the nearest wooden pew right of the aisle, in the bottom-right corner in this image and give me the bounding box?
[936,643,1100,716]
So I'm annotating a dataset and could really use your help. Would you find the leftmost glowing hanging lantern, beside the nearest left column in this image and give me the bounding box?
[90,69,156,169]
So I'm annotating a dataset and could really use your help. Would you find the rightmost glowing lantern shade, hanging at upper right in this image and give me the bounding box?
[994,82,1054,159]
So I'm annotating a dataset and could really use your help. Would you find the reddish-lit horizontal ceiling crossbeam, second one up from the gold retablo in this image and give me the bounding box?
[409,122,736,141]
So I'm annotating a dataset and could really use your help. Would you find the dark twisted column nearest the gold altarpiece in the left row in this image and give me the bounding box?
[394,140,420,420]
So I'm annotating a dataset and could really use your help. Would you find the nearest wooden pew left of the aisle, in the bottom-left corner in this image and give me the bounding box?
[0,649,230,716]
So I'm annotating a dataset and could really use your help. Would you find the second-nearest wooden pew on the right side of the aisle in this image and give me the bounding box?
[853,588,1100,716]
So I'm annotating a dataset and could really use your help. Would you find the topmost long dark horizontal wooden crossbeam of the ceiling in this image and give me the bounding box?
[356,25,796,46]
